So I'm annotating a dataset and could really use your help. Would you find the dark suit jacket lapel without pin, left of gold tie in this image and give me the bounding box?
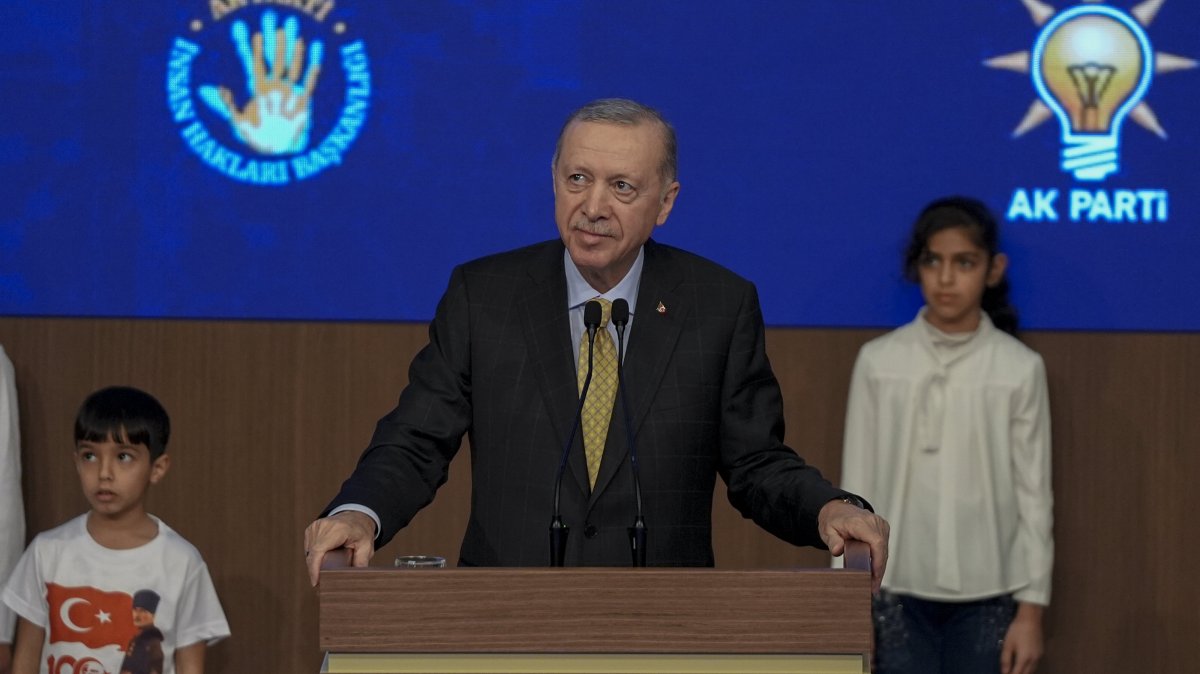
[520,242,588,493]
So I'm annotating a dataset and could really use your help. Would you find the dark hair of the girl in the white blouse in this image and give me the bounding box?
[904,197,1018,336]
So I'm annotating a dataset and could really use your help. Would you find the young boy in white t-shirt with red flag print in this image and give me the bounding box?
[4,387,229,674]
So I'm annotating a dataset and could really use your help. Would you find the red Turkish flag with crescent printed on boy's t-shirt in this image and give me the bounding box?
[46,583,138,650]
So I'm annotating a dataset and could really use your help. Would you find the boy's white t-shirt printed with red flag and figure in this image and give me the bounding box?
[4,513,229,674]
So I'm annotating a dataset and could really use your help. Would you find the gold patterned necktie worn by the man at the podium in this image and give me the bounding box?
[578,297,617,487]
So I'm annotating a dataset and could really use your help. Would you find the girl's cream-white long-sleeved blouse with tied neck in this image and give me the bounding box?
[841,309,1054,606]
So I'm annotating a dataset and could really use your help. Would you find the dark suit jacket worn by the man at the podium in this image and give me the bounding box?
[325,240,844,566]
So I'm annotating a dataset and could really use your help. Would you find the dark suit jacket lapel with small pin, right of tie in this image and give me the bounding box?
[581,241,690,507]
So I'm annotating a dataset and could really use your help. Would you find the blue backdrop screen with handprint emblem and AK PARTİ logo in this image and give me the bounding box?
[0,0,1200,331]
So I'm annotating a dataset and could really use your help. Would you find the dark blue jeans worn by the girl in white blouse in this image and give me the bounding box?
[871,591,1016,674]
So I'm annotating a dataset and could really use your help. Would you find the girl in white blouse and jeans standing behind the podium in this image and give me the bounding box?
[842,197,1054,674]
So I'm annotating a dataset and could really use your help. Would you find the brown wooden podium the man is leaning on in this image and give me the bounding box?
[319,543,871,674]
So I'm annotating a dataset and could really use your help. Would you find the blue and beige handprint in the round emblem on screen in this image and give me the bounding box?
[199,10,324,155]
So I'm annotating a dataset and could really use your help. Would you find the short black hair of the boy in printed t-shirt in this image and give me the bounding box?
[76,386,170,461]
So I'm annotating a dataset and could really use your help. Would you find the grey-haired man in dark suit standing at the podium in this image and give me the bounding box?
[305,100,888,585]
